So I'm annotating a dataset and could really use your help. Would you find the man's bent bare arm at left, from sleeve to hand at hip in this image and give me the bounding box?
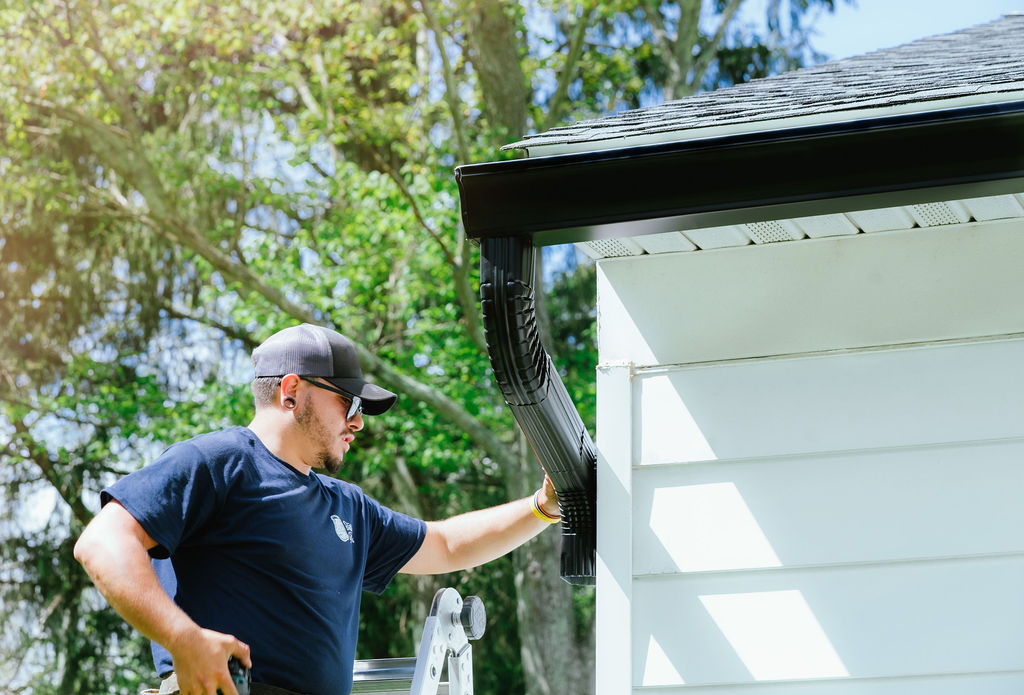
[75,501,252,695]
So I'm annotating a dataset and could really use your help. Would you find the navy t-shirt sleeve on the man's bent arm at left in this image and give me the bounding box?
[100,442,226,558]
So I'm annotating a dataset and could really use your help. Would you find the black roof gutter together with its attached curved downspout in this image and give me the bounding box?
[456,101,1024,583]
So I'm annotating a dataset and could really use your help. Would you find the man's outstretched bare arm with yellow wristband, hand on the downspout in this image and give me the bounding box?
[400,477,558,574]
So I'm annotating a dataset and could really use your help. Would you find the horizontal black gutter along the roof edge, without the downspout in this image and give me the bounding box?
[456,101,1024,246]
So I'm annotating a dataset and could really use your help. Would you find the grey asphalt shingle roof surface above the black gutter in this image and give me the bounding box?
[506,12,1024,148]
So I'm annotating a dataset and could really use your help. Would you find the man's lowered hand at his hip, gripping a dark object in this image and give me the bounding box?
[168,627,252,695]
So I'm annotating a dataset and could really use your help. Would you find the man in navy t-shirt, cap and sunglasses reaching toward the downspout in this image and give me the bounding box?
[75,323,558,695]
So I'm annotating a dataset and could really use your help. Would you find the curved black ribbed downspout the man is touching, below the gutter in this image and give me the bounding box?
[480,236,597,584]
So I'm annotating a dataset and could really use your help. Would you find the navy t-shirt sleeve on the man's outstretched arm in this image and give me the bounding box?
[362,497,427,594]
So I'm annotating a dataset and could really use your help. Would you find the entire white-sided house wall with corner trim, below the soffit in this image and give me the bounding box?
[597,222,1024,695]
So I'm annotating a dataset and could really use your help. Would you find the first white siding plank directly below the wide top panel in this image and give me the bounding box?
[634,339,1024,465]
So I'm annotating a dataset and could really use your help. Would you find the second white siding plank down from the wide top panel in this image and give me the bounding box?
[633,438,1024,577]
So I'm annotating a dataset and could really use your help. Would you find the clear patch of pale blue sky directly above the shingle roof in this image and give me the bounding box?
[814,0,1024,58]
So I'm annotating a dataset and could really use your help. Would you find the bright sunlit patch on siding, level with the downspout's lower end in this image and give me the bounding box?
[650,482,782,572]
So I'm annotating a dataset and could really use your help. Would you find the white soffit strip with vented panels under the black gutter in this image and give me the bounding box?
[577,193,1024,260]
